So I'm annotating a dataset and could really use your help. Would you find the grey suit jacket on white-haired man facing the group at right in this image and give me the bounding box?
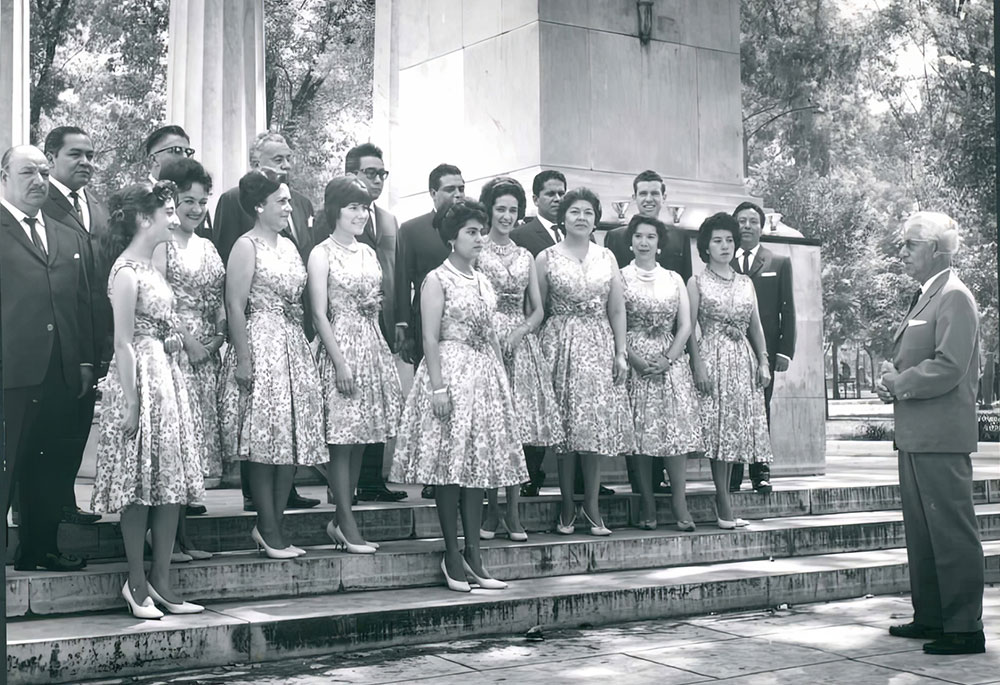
[893,271,979,453]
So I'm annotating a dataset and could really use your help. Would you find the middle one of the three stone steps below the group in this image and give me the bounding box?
[7,504,1000,616]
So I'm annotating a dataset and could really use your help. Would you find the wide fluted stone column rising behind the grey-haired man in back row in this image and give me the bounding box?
[166,0,266,197]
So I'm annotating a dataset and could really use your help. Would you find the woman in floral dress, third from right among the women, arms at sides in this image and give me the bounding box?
[536,188,635,535]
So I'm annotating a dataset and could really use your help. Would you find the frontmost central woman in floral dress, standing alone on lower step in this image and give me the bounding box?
[391,201,527,592]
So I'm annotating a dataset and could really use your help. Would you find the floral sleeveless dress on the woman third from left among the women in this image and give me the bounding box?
[219,236,329,466]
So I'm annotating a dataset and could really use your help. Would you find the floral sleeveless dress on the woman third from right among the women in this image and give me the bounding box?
[540,245,635,456]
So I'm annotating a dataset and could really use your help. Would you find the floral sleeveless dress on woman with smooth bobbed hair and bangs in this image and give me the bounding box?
[315,237,403,445]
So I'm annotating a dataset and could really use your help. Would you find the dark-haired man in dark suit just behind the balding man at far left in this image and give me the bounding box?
[42,126,114,524]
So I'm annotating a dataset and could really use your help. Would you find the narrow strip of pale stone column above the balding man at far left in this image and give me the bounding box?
[0,0,31,152]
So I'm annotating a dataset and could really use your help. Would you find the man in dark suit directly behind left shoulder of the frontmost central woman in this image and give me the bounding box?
[394,164,465,499]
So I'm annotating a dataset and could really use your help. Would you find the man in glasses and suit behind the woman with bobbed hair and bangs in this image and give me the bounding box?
[316,143,406,502]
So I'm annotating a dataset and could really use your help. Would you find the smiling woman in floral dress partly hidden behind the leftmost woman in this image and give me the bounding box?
[153,159,226,560]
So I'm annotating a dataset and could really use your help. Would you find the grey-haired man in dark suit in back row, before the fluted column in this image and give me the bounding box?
[213,132,319,511]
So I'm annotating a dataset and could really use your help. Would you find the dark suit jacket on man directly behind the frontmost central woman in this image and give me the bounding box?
[395,212,449,332]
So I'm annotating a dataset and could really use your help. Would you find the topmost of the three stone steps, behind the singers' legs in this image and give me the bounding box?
[15,479,1000,563]
